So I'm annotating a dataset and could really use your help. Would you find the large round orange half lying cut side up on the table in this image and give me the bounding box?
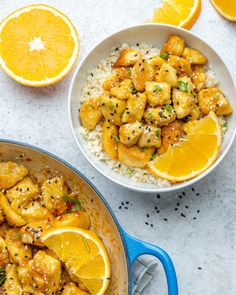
[0,4,79,87]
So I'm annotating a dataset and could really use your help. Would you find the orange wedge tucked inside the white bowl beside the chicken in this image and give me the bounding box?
[149,112,222,182]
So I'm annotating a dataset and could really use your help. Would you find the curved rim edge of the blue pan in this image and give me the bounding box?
[0,138,132,295]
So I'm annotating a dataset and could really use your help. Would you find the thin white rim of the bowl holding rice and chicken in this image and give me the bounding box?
[68,23,236,193]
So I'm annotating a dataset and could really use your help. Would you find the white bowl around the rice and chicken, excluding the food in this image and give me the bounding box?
[69,24,236,193]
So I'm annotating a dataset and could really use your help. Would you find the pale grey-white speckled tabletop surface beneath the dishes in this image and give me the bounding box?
[0,0,236,295]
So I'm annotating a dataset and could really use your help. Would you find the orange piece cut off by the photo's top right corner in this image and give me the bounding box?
[211,0,236,21]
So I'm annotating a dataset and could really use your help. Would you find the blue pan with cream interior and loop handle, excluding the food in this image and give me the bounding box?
[0,140,178,295]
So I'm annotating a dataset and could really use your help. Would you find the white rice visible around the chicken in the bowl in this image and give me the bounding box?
[77,43,221,187]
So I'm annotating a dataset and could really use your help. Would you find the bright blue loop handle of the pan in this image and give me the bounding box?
[123,231,178,295]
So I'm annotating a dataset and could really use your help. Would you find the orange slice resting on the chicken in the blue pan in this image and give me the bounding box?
[41,227,111,295]
